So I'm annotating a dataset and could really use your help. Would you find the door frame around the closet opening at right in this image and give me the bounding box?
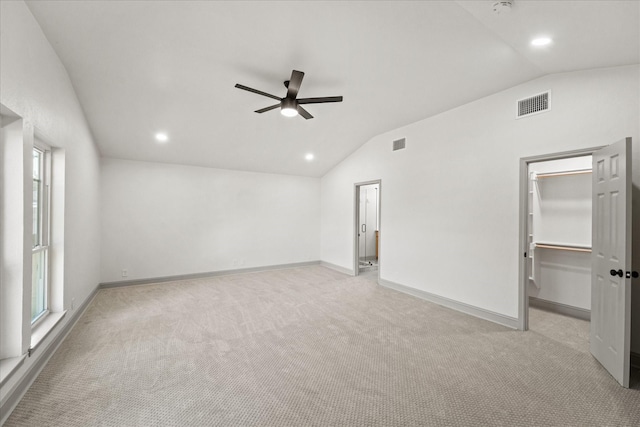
[518,145,606,331]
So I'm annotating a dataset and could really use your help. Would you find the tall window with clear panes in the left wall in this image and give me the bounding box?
[31,148,50,325]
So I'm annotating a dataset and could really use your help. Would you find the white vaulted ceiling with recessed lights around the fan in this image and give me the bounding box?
[27,0,640,176]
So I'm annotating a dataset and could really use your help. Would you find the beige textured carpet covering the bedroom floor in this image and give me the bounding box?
[6,266,640,426]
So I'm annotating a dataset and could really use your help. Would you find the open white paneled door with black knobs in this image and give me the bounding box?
[590,138,632,387]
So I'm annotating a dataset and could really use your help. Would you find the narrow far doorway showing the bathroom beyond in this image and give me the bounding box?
[354,180,381,278]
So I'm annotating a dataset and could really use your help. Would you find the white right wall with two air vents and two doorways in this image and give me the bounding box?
[321,65,640,342]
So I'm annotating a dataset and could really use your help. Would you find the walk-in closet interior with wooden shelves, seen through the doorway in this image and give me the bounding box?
[527,156,592,319]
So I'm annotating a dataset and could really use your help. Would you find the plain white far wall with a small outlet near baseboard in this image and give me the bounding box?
[100,158,320,282]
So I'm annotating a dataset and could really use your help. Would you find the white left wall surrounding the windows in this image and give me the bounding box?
[0,1,100,412]
